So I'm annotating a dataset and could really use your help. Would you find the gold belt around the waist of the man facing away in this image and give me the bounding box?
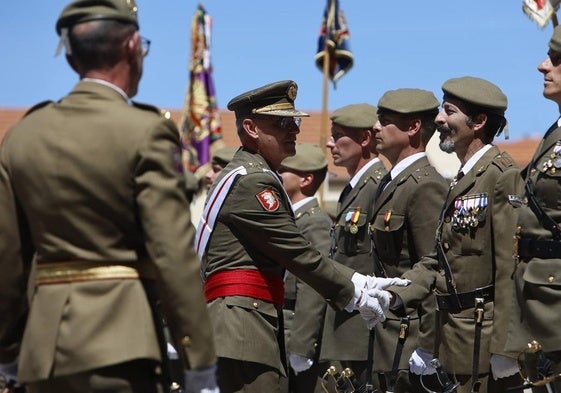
[35,261,141,286]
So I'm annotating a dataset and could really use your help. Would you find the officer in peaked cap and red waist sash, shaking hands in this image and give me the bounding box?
[195,80,406,393]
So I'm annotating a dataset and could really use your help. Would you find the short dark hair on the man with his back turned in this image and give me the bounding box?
[68,20,137,69]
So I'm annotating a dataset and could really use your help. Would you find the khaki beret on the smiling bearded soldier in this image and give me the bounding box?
[442,76,507,116]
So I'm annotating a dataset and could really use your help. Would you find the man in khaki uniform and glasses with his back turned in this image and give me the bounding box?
[0,0,218,392]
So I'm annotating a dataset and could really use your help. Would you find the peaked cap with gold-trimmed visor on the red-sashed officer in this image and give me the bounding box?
[228,80,310,118]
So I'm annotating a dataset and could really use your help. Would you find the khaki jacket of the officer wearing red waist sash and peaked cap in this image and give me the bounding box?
[202,148,354,372]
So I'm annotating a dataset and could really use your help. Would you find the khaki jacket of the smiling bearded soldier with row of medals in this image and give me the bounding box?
[390,147,519,375]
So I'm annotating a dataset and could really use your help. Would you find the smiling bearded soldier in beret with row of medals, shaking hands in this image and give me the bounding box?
[382,77,520,392]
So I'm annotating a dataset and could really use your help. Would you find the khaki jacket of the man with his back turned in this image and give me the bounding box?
[0,82,216,382]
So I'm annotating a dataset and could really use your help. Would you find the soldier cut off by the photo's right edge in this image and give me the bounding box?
[507,26,561,392]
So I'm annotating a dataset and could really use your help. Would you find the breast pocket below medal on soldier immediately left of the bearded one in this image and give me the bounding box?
[372,212,405,264]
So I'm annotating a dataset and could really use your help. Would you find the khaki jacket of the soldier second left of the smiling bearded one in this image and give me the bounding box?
[321,161,387,360]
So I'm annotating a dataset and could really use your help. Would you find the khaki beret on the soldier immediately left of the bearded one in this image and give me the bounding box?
[378,89,440,114]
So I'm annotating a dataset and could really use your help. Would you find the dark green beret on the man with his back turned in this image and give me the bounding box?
[56,0,138,35]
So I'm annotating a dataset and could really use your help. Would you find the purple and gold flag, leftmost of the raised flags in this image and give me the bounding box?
[180,4,223,172]
